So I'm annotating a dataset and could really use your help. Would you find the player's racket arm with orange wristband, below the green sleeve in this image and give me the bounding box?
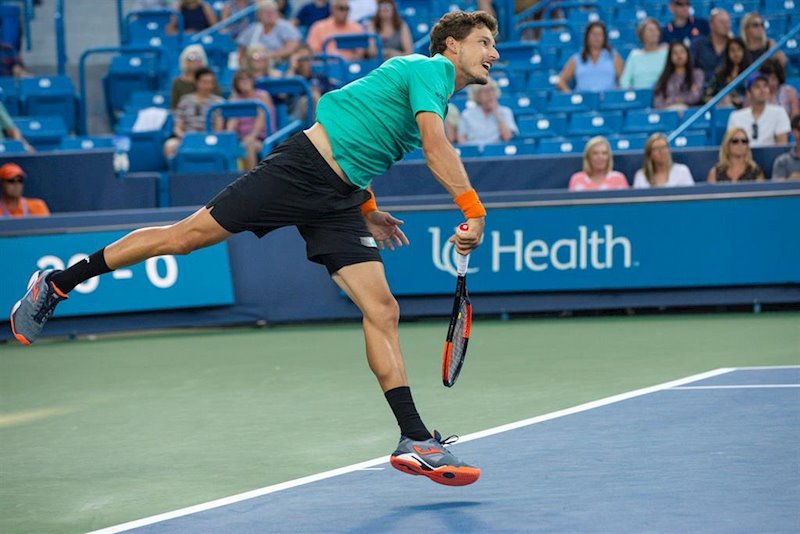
[417,112,486,254]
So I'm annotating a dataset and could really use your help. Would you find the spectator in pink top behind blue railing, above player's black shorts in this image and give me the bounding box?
[226,70,276,169]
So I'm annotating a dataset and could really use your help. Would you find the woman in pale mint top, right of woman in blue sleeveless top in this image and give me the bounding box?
[619,17,668,89]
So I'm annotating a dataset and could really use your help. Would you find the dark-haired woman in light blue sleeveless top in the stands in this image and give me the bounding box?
[558,21,623,92]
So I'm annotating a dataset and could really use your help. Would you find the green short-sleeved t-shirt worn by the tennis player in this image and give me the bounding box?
[317,54,456,189]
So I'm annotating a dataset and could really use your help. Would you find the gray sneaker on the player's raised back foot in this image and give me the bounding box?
[11,269,67,345]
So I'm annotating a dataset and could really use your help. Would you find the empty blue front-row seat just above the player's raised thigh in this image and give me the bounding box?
[171,132,244,173]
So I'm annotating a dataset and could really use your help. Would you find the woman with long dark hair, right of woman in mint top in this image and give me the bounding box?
[653,41,703,112]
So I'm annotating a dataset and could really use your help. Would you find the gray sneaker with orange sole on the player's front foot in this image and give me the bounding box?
[389,430,481,486]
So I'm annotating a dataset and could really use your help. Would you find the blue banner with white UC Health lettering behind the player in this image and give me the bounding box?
[383,196,800,295]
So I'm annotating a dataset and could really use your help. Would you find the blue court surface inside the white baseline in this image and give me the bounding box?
[97,366,800,533]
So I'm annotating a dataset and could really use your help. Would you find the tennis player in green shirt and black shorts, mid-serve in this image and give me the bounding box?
[11,11,499,486]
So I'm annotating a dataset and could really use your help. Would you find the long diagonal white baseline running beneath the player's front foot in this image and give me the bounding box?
[89,368,737,534]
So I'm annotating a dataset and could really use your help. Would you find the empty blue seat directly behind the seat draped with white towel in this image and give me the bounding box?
[103,54,161,123]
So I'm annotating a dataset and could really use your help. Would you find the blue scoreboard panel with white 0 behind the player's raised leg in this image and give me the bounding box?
[0,232,233,317]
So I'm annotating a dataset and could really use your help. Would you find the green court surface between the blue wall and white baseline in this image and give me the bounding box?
[0,312,800,533]
